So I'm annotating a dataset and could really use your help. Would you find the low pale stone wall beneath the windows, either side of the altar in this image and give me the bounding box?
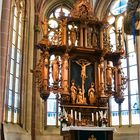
[1,124,140,140]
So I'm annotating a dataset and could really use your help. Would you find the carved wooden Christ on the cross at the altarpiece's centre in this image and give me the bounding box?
[76,59,91,98]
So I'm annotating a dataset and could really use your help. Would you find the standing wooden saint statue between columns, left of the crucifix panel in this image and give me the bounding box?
[52,56,59,83]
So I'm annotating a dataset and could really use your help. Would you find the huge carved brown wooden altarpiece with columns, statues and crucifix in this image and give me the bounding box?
[34,0,126,138]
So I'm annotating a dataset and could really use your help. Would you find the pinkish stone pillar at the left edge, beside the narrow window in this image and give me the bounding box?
[0,0,11,123]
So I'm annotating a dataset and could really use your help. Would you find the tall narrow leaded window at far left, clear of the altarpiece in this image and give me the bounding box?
[5,0,25,123]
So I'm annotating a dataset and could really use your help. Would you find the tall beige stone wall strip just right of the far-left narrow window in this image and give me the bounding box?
[22,0,34,132]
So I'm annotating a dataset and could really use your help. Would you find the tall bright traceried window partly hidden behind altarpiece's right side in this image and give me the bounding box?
[108,0,140,126]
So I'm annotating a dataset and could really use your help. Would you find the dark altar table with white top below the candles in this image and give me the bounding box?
[63,126,114,140]
